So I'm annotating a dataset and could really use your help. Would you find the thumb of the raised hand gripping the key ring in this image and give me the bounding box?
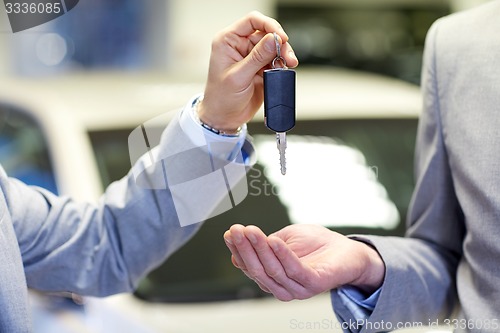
[239,33,281,78]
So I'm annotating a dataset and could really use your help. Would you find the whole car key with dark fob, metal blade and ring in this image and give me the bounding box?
[264,33,295,175]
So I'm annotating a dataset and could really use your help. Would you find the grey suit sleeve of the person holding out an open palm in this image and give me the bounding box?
[332,18,464,332]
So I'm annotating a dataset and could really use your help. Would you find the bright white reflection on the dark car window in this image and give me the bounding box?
[255,135,400,229]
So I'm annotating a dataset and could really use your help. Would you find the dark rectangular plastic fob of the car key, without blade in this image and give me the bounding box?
[264,68,295,133]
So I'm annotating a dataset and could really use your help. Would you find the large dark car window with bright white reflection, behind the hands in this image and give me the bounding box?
[90,118,417,302]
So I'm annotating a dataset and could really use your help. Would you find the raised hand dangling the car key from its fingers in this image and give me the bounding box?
[198,12,298,132]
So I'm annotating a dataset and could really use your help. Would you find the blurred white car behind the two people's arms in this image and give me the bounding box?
[0,67,436,333]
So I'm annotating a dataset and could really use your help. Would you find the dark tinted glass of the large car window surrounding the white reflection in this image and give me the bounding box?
[90,118,417,302]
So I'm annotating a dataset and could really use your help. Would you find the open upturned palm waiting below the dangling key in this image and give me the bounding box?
[225,225,383,301]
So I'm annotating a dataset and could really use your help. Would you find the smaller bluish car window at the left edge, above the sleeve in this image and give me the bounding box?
[0,104,58,194]
